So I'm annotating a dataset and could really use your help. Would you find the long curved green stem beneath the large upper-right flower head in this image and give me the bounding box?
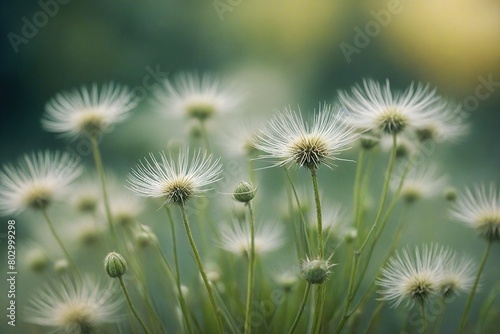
[335,135,397,334]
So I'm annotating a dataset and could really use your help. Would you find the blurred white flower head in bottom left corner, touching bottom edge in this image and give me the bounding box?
[26,276,121,334]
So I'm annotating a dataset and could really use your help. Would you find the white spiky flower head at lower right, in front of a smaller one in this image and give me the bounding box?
[376,245,446,307]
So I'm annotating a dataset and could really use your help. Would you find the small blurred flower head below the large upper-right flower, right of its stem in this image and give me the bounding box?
[391,165,446,203]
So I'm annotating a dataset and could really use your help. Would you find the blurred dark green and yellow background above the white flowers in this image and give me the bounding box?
[0,0,500,332]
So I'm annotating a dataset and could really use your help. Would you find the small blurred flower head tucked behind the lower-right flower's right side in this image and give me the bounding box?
[439,250,475,298]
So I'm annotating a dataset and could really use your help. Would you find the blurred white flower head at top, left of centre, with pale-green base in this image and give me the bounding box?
[156,73,242,121]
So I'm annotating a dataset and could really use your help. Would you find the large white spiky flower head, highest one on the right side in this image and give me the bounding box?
[339,80,446,134]
